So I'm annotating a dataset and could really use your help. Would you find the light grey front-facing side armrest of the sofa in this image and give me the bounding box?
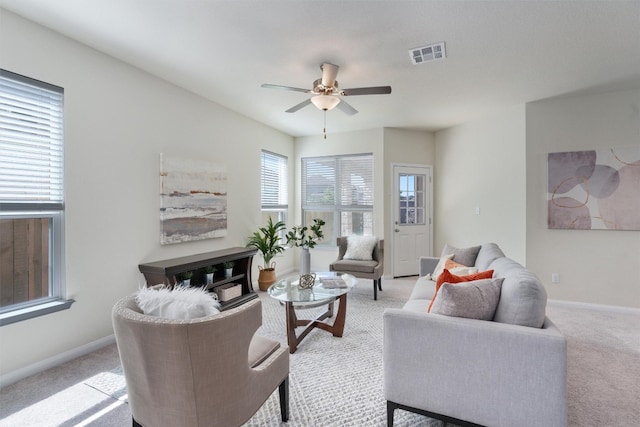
[383,309,567,427]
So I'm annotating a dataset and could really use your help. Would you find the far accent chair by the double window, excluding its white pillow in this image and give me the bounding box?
[329,236,384,300]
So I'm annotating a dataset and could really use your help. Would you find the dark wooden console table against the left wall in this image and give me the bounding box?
[138,247,258,310]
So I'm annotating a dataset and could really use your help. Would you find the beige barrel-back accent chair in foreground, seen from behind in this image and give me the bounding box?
[112,295,289,427]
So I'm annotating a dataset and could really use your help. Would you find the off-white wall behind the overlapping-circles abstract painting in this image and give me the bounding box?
[526,90,640,308]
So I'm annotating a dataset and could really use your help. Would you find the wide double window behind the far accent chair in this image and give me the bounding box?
[301,153,374,247]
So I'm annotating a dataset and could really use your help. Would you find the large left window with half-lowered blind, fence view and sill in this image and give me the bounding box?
[0,70,73,325]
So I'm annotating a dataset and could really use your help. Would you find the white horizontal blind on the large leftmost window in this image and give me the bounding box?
[0,70,64,206]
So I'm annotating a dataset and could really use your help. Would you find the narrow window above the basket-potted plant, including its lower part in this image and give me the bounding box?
[261,150,289,239]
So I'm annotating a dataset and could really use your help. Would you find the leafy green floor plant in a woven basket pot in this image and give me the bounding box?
[247,217,285,291]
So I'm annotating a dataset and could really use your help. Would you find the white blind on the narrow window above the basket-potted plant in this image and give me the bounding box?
[261,150,289,209]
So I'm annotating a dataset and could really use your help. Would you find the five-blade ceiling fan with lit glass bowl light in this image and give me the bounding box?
[262,63,391,116]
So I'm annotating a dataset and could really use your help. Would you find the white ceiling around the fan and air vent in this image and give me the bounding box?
[0,0,640,136]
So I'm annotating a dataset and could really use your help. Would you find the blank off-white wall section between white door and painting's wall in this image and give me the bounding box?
[434,105,527,264]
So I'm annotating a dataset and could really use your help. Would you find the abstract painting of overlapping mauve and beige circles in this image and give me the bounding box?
[547,145,640,230]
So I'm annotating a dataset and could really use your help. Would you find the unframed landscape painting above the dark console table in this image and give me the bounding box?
[160,154,227,245]
